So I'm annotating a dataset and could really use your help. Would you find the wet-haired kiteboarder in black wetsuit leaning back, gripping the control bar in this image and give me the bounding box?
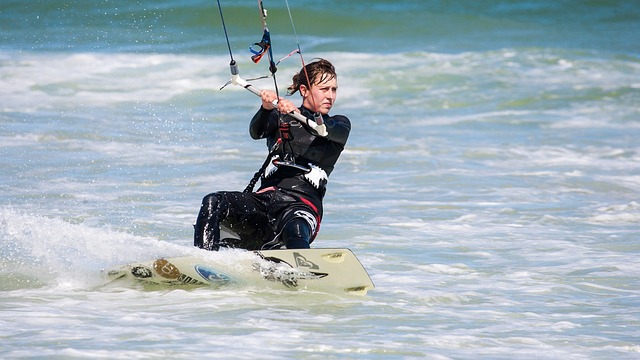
[194,59,351,250]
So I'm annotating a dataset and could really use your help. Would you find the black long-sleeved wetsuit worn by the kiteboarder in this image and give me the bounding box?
[194,107,351,250]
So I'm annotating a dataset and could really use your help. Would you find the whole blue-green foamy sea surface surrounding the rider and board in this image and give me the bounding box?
[0,0,640,359]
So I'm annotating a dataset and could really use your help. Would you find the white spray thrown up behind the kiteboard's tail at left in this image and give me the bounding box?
[0,208,191,288]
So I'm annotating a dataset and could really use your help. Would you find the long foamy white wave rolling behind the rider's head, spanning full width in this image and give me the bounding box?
[0,48,640,128]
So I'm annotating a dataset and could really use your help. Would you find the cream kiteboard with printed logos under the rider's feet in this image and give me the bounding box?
[106,249,374,295]
